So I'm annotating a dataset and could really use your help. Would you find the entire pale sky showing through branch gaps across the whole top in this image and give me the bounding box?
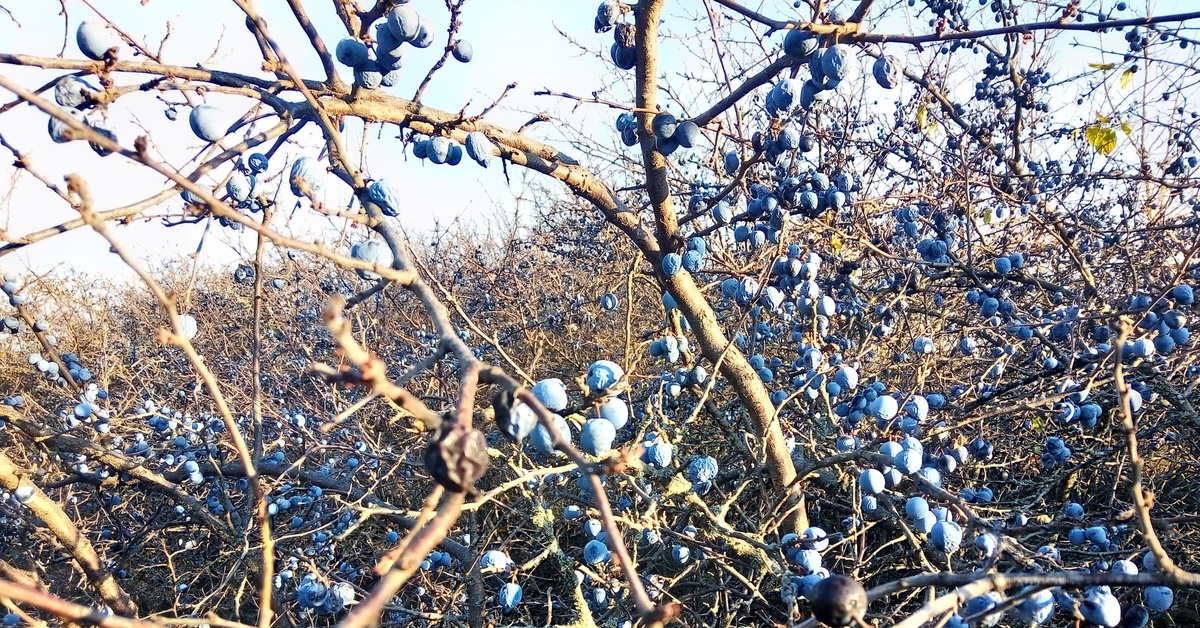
[0,0,1194,275]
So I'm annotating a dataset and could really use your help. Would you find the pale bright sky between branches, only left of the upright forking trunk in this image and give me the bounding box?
[0,0,611,277]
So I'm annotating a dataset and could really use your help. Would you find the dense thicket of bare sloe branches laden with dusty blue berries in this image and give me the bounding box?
[0,0,1200,628]
